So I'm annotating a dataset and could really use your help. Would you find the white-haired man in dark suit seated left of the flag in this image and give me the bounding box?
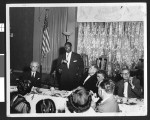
[21,61,41,87]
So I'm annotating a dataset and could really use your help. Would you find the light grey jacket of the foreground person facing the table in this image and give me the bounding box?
[96,96,120,113]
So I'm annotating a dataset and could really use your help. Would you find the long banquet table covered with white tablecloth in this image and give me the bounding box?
[10,86,147,116]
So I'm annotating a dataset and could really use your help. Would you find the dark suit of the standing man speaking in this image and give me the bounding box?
[57,52,84,90]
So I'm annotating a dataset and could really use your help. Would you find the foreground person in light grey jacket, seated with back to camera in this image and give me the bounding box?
[95,79,119,113]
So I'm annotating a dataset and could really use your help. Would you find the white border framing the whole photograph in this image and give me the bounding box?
[6,2,147,117]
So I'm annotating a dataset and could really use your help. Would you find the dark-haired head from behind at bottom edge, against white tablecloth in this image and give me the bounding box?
[36,99,56,113]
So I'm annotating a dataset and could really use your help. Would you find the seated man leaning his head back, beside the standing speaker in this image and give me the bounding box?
[82,65,98,93]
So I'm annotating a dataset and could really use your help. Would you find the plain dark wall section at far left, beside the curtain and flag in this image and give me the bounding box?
[10,7,34,70]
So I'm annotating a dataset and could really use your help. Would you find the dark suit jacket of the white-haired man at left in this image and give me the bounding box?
[21,71,41,87]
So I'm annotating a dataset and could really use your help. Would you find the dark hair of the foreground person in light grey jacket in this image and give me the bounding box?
[99,79,115,93]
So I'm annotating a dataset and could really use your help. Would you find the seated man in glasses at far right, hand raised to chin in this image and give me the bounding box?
[116,68,143,98]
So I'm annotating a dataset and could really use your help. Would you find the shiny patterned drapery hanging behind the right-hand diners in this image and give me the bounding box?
[77,21,144,68]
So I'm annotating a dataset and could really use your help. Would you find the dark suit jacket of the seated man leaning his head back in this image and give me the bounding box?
[82,73,98,93]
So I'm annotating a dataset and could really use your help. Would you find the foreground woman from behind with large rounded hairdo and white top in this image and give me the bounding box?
[66,87,95,114]
